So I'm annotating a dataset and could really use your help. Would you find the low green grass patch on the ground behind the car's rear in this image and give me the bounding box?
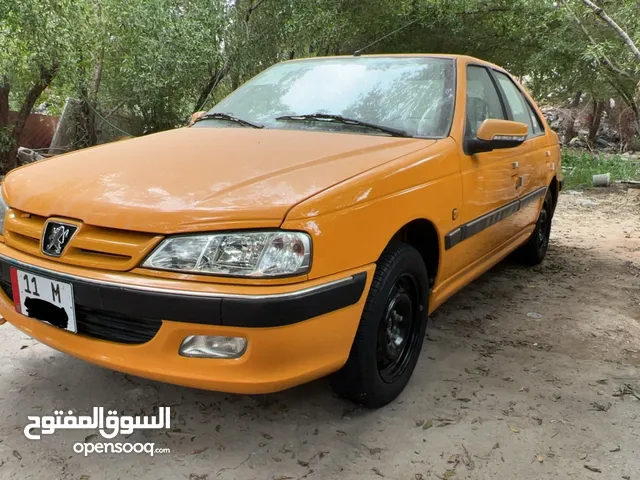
[562,149,640,189]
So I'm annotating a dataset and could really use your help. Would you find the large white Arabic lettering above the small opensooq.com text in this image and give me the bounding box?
[24,407,171,440]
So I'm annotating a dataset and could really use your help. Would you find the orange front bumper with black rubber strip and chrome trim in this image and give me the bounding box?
[0,246,375,393]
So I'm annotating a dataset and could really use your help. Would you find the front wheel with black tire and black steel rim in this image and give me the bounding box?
[330,243,429,408]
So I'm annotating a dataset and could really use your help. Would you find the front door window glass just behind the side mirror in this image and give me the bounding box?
[467,65,505,138]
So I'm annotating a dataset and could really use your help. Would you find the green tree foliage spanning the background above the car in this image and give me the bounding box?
[0,0,640,156]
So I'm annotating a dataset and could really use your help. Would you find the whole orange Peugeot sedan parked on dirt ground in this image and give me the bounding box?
[0,55,562,407]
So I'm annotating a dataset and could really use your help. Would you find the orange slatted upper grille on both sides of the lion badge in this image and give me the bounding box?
[4,209,162,271]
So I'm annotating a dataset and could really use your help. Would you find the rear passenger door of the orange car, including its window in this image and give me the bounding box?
[494,70,555,230]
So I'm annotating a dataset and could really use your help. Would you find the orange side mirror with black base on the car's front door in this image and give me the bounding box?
[465,118,529,155]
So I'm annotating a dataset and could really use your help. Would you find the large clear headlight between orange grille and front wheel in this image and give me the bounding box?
[142,231,311,277]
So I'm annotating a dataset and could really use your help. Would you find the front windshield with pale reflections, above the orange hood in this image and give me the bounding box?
[196,57,455,138]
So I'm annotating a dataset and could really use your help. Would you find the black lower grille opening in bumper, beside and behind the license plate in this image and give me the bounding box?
[0,280,162,345]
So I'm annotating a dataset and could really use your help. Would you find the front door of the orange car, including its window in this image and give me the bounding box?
[448,64,524,270]
